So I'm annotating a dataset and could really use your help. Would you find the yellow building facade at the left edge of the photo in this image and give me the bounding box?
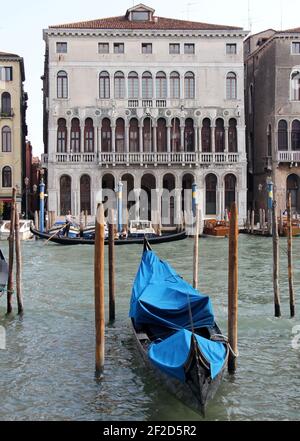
[0,52,27,218]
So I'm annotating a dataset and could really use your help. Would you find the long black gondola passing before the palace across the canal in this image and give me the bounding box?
[31,227,187,245]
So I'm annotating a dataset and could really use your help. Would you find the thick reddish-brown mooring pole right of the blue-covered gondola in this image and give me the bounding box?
[228,202,239,372]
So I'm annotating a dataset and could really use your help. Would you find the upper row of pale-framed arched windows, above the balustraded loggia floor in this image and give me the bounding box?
[57,70,237,99]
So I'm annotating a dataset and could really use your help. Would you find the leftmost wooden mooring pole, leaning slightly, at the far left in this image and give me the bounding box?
[7,188,17,314]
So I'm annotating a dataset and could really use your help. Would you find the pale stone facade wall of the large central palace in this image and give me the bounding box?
[44,20,247,223]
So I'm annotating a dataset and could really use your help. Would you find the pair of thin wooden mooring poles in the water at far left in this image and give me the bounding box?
[7,188,23,314]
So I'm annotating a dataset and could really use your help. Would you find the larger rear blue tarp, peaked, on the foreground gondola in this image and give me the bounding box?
[129,250,214,330]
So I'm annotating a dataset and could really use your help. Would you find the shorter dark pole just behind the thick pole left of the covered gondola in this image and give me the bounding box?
[108,210,116,323]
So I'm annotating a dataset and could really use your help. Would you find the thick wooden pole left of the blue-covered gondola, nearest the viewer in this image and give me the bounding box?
[94,204,105,376]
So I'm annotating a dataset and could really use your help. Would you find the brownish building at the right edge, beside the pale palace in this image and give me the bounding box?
[245,28,300,213]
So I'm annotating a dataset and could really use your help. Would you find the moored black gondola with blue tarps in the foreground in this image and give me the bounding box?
[129,240,229,415]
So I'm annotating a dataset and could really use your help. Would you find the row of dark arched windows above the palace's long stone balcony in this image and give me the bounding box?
[57,118,237,153]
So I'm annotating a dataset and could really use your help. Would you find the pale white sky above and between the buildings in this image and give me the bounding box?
[0,0,300,155]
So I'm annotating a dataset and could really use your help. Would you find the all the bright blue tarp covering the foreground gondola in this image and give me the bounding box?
[129,251,226,381]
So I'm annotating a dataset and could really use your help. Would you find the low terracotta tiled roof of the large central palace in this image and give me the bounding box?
[49,16,243,31]
